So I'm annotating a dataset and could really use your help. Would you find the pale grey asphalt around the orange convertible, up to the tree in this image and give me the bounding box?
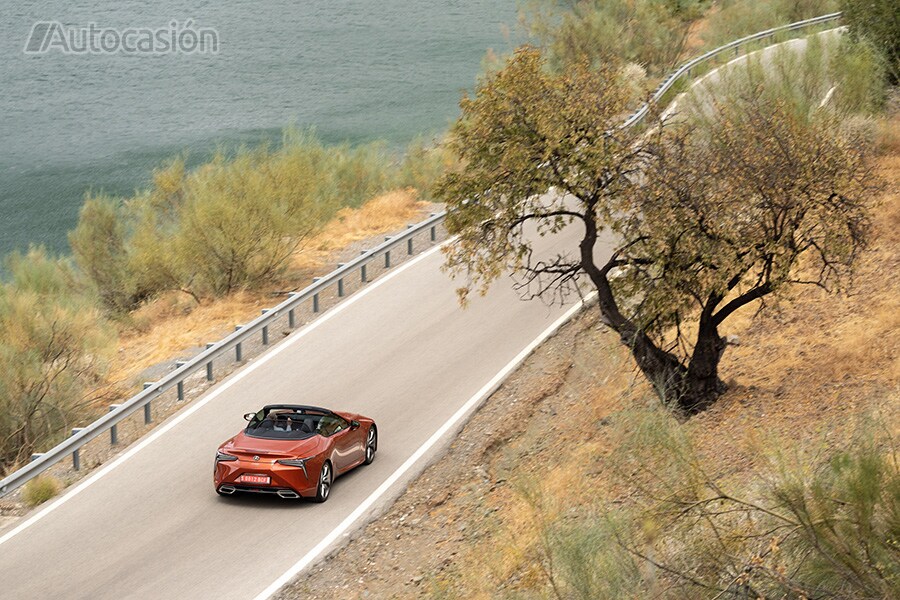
[0,218,596,600]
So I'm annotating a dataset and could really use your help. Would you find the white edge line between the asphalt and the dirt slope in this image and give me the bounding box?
[254,292,597,600]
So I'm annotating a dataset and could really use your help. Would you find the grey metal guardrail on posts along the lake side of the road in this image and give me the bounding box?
[0,12,841,497]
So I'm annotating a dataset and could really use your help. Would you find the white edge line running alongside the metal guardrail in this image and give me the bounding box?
[0,238,455,545]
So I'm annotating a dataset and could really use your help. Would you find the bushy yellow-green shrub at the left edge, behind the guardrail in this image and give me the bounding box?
[0,249,113,469]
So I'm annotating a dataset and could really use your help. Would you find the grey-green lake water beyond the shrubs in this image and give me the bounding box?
[0,0,516,254]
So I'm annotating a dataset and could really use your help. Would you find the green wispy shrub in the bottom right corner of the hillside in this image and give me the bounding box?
[769,439,900,598]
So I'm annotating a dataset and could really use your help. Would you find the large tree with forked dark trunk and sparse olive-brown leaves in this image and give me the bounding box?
[437,47,869,413]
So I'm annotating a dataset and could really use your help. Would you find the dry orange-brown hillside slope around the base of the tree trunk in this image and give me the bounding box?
[280,112,900,598]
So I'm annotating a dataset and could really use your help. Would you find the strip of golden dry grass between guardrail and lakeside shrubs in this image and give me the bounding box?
[108,189,428,391]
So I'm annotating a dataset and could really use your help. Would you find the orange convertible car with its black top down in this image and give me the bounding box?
[213,404,378,502]
